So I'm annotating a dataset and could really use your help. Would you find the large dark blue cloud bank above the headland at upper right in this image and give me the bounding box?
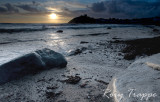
[89,0,160,18]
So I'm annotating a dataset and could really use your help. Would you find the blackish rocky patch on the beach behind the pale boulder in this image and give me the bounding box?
[112,36,160,60]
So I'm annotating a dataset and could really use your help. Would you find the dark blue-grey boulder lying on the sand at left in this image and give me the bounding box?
[0,48,67,84]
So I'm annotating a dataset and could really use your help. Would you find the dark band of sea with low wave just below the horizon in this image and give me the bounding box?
[0,23,138,34]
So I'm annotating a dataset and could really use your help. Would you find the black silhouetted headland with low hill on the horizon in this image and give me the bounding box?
[68,15,160,26]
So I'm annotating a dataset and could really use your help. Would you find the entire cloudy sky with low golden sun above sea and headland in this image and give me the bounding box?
[0,0,160,23]
